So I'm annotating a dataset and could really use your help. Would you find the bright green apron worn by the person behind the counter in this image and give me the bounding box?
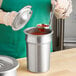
[0,0,52,58]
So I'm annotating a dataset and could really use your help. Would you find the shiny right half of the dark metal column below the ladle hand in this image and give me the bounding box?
[57,19,65,50]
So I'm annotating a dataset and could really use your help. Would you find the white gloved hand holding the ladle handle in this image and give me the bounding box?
[51,0,72,19]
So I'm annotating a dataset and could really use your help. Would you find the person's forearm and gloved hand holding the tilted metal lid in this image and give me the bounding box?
[0,0,17,26]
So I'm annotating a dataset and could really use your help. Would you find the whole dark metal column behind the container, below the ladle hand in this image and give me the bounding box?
[53,16,65,51]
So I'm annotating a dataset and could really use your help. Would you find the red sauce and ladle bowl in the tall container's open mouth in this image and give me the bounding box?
[27,24,50,35]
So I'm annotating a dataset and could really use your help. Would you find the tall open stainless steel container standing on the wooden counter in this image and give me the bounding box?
[24,27,53,73]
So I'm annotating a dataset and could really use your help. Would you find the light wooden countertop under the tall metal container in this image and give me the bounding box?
[17,48,76,76]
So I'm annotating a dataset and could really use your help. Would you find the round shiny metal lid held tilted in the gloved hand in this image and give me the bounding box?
[12,6,32,31]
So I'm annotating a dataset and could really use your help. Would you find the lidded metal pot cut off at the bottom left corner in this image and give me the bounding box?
[0,55,19,76]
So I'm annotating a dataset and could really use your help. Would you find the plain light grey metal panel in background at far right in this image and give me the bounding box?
[64,0,76,42]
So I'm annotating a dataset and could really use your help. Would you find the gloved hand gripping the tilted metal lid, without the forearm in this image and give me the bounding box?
[3,11,17,26]
